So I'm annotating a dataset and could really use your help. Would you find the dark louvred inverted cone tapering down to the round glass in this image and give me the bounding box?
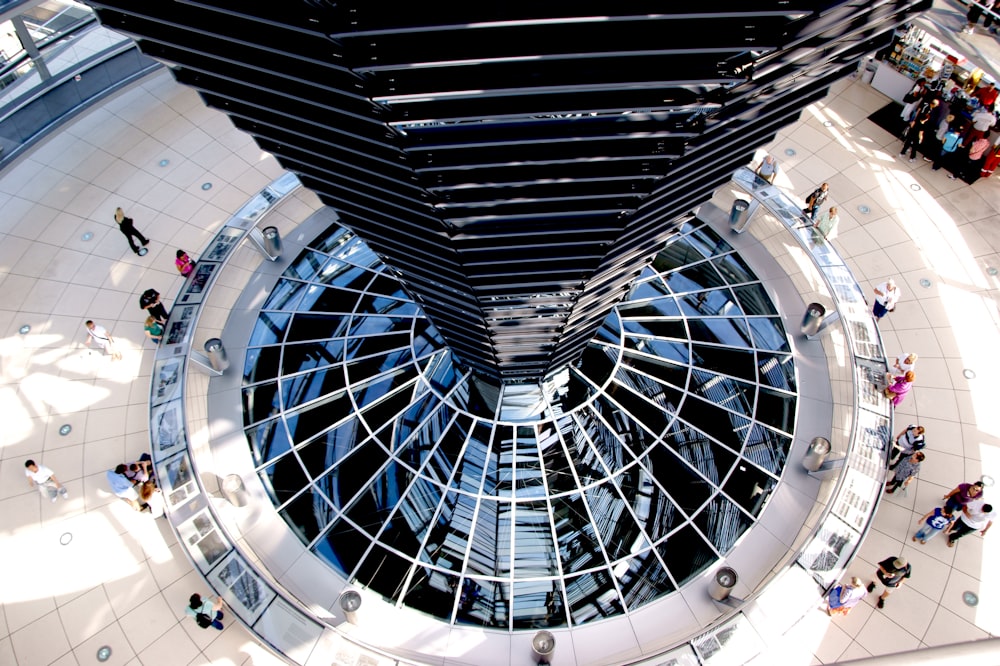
[87,0,931,383]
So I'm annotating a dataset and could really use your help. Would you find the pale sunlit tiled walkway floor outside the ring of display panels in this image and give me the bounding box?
[0,32,1000,665]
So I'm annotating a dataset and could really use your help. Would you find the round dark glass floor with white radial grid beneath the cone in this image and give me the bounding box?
[243,219,796,630]
